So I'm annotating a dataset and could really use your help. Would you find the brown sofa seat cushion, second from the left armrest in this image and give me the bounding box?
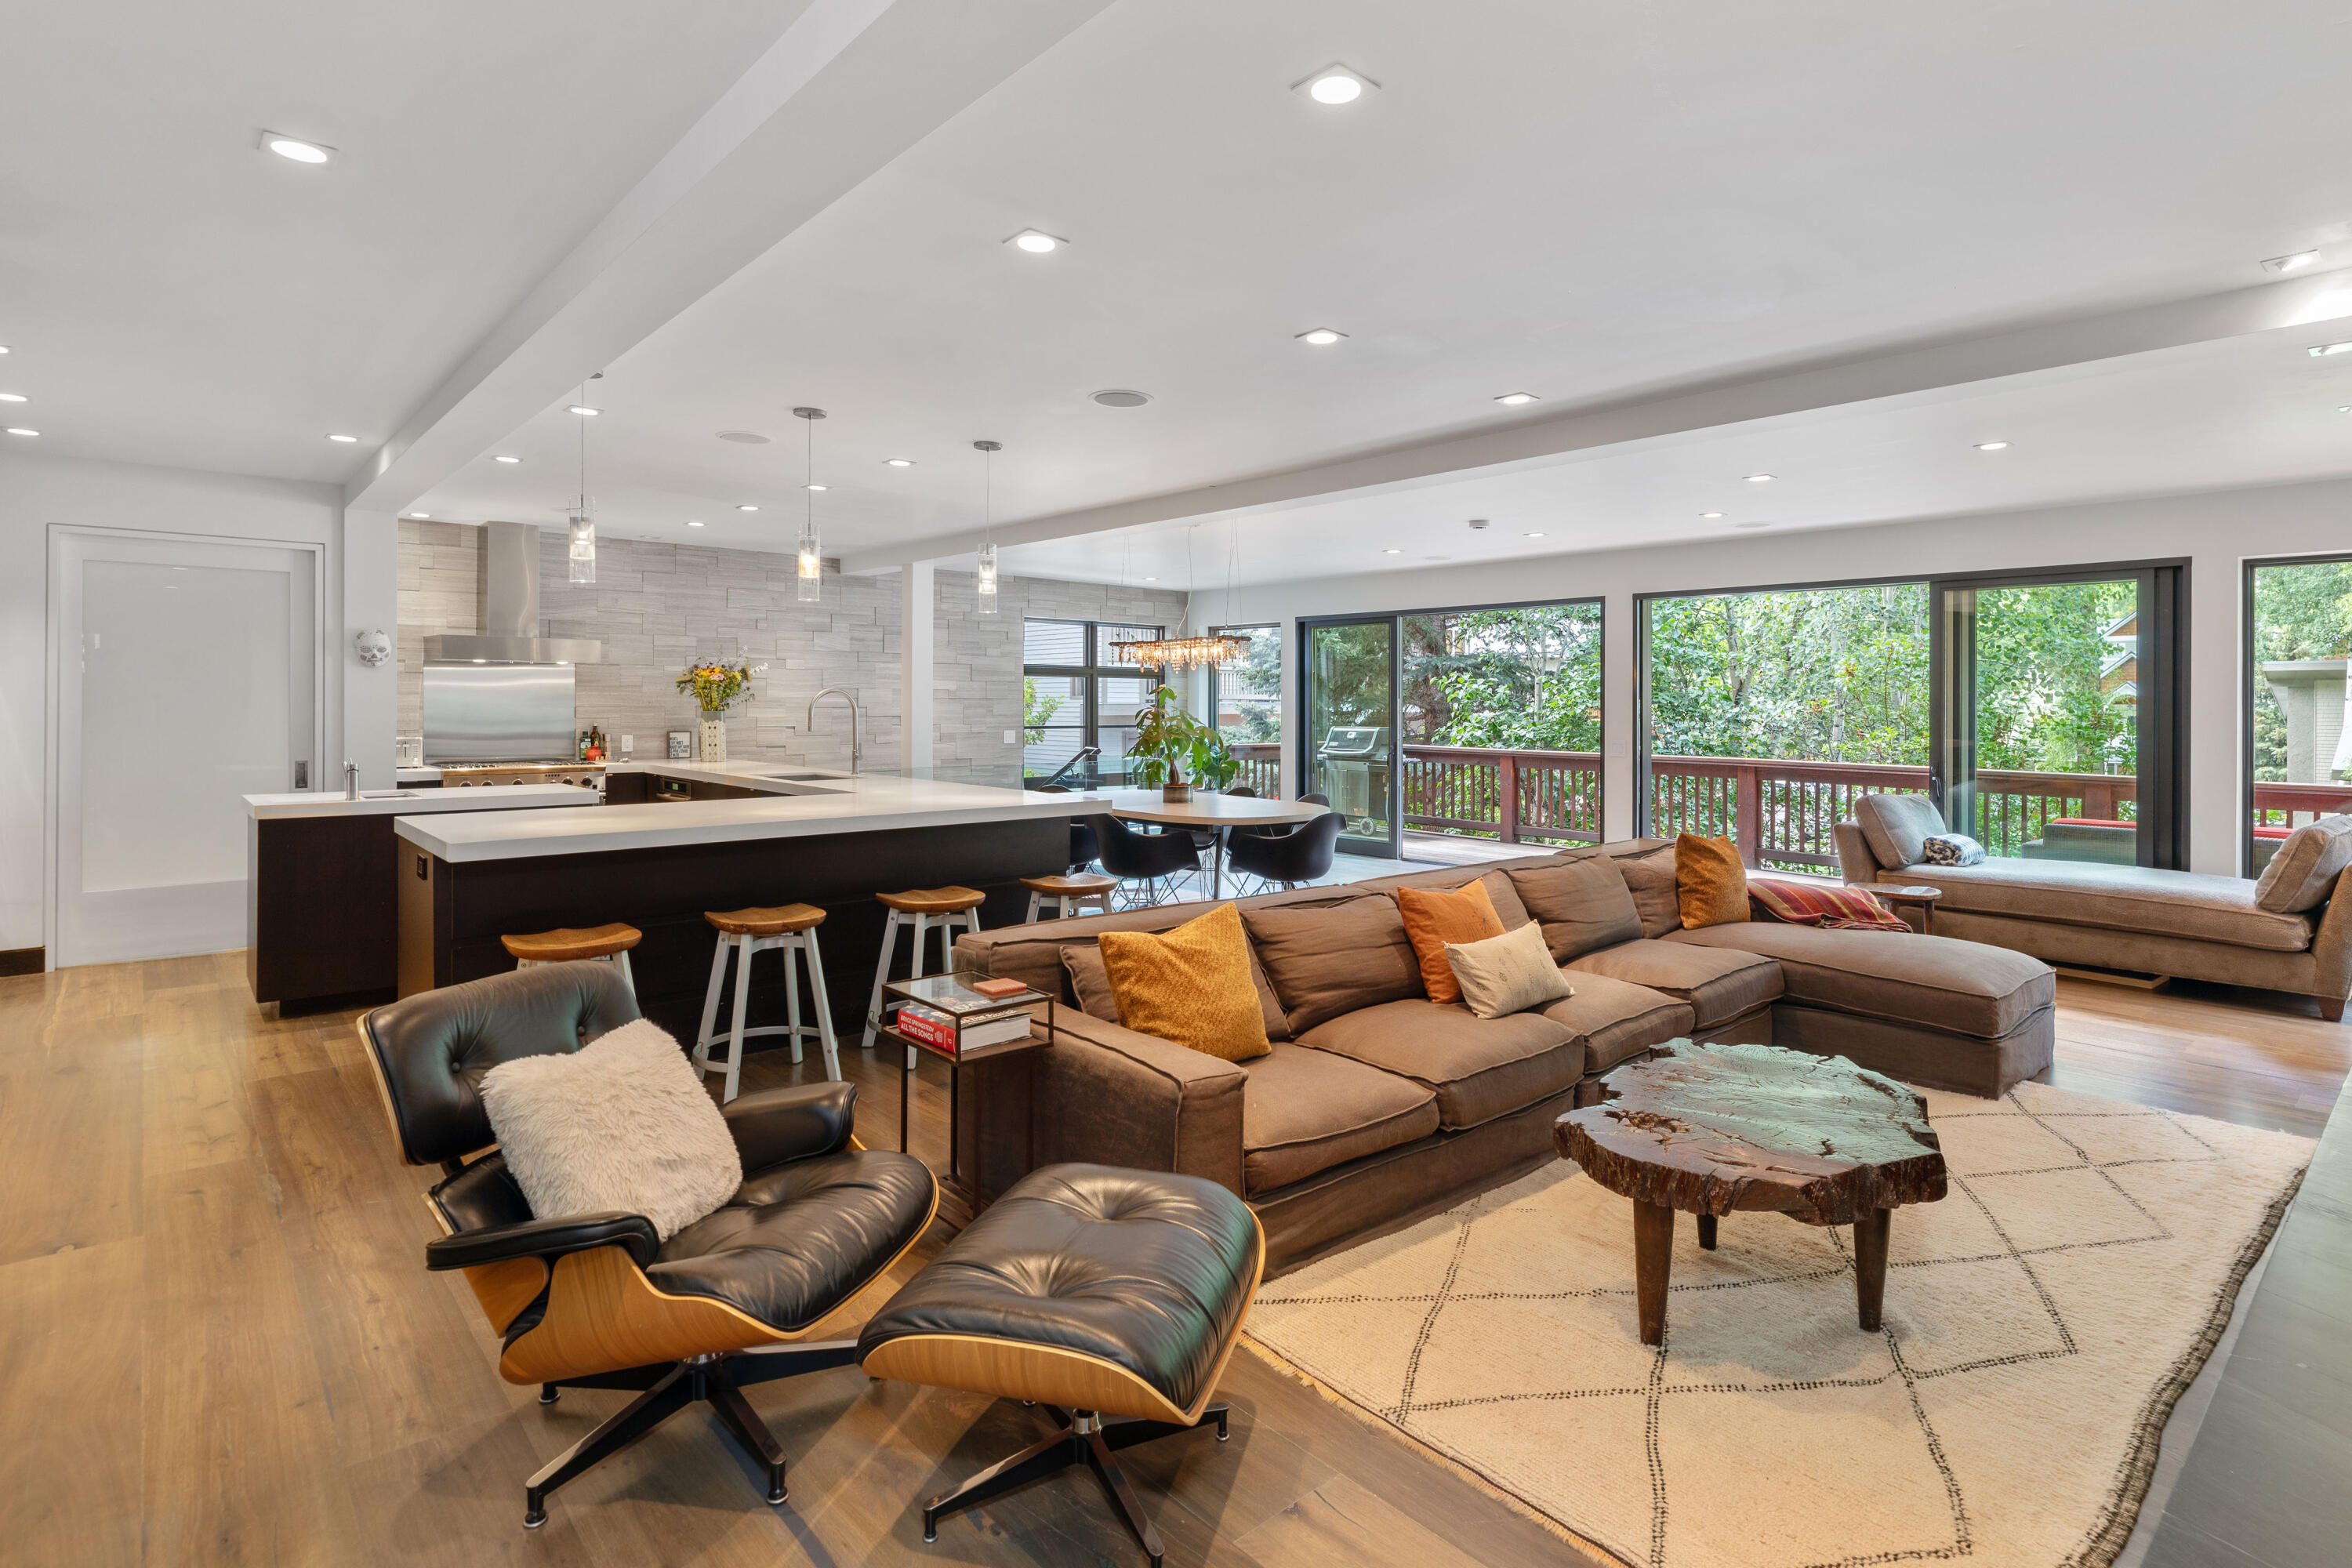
[1298,996,1585,1128]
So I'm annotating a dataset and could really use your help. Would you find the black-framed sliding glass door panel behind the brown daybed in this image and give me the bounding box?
[1931,567,2183,865]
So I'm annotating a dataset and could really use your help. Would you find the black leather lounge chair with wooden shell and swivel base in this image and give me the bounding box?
[360,964,938,1528]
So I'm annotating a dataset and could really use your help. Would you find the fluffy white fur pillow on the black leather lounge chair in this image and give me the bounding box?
[482,1018,743,1241]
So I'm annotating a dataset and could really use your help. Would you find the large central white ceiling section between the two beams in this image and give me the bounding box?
[419,0,2352,576]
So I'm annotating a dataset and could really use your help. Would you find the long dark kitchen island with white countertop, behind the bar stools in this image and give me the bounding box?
[395,762,1087,1041]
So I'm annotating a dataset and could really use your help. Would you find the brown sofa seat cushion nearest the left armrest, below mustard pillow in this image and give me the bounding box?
[1242,1044,1437,1194]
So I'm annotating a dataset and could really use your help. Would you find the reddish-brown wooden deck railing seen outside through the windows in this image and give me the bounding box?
[1235,746,2352,874]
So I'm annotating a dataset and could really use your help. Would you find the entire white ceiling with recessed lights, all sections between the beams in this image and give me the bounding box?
[13,0,2352,586]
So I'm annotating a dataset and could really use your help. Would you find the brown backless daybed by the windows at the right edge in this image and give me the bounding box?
[1837,794,2352,1020]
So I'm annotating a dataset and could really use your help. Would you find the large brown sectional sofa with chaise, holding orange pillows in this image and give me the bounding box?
[957,839,2056,1269]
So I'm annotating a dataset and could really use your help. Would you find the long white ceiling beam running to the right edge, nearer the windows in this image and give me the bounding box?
[842,268,2352,574]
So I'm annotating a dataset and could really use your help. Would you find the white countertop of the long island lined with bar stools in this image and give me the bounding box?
[393,762,1084,862]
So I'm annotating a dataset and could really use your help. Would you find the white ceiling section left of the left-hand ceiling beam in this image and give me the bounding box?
[0,0,807,480]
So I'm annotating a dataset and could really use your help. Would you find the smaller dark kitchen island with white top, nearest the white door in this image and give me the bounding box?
[245,785,597,1018]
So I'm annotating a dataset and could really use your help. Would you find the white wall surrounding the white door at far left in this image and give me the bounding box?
[0,452,358,949]
